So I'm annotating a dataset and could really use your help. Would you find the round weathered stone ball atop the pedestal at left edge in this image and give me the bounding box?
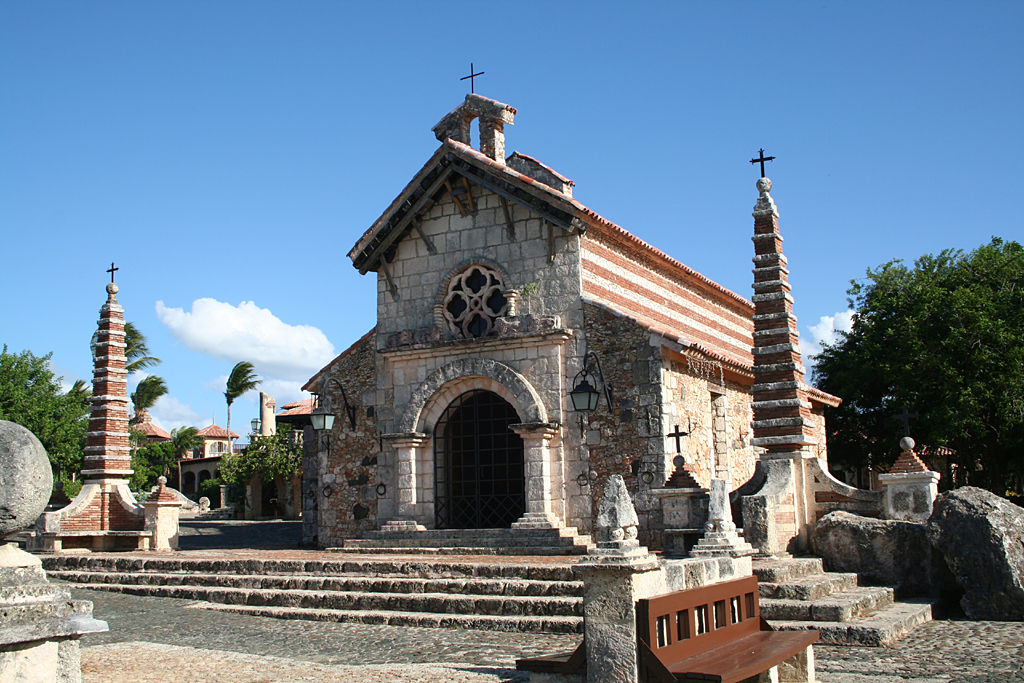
[0,420,53,539]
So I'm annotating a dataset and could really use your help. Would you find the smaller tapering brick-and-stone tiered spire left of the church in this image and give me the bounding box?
[82,283,132,480]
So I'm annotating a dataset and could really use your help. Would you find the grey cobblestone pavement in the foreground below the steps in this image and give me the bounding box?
[67,584,1024,683]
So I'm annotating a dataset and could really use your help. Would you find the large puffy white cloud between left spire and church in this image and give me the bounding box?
[157,298,335,382]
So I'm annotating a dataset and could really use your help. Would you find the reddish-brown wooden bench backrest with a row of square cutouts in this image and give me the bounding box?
[637,577,761,663]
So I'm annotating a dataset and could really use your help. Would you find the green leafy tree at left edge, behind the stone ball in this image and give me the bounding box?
[0,345,89,474]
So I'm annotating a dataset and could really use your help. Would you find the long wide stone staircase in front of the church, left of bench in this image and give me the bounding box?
[42,552,583,634]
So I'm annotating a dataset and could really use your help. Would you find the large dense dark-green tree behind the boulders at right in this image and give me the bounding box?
[814,238,1024,495]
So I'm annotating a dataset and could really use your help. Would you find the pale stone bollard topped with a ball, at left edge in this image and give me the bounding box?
[0,420,108,683]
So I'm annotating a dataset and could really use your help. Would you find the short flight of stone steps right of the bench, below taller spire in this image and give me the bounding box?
[754,557,934,646]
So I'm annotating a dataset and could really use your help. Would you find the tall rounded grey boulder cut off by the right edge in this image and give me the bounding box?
[928,486,1024,622]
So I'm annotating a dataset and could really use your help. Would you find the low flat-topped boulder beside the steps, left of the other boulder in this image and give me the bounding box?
[811,510,934,596]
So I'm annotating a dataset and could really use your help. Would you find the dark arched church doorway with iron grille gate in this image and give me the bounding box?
[434,389,526,528]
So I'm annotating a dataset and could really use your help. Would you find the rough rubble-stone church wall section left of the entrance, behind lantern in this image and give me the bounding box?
[314,327,380,548]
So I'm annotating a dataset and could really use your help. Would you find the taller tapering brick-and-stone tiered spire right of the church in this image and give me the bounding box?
[753,177,817,458]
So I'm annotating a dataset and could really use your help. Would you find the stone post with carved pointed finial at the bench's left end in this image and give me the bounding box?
[572,474,666,683]
